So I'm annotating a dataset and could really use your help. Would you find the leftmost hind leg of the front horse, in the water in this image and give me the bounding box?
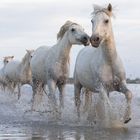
[74,82,82,119]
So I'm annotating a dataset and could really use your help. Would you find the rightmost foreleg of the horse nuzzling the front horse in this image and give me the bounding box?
[58,84,65,108]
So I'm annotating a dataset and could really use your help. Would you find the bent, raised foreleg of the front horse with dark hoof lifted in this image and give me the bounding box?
[119,84,132,123]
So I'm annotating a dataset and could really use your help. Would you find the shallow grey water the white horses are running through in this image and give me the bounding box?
[0,85,140,140]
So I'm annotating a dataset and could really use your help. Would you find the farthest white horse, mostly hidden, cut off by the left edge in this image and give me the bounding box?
[0,56,14,90]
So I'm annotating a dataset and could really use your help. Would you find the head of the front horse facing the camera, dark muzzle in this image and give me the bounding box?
[90,4,112,48]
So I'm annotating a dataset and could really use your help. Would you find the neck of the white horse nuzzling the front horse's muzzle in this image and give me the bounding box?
[57,33,72,64]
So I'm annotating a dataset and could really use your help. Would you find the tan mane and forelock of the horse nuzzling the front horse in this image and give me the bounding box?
[57,21,78,40]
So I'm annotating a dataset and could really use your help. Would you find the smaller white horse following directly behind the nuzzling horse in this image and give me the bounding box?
[4,50,34,99]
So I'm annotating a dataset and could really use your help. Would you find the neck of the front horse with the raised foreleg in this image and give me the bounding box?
[100,32,117,65]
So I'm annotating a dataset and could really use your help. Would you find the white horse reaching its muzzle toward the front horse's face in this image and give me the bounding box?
[31,21,90,111]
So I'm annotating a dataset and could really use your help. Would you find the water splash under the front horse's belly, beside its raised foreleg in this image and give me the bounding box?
[82,87,125,128]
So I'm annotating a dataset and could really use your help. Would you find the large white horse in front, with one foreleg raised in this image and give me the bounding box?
[74,4,132,123]
